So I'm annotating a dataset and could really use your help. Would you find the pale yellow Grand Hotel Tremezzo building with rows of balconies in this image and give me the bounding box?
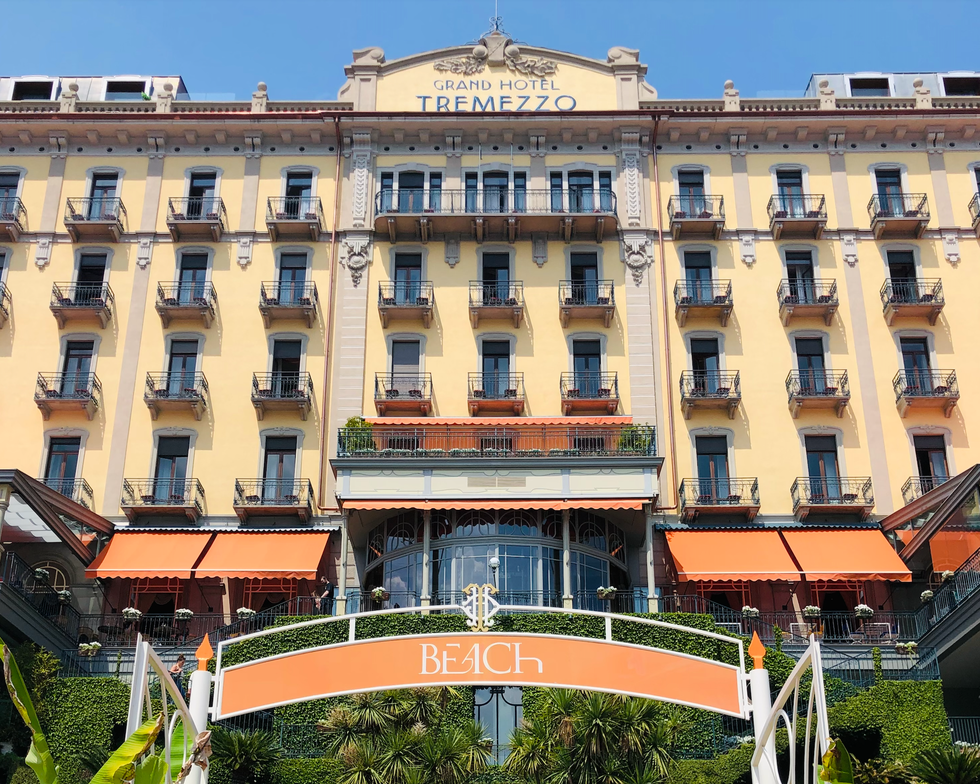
[0,30,980,712]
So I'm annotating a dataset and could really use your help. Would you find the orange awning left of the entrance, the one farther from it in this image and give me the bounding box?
[85,531,214,580]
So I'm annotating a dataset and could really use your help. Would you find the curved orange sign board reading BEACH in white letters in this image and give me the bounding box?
[216,633,745,718]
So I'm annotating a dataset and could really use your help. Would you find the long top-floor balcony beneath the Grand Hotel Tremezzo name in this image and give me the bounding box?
[374,188,619,242]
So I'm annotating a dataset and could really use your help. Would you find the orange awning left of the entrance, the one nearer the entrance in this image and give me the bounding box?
[194,532,330,580]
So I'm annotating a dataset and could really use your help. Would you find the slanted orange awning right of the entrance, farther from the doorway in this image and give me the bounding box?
[783,528,912,583]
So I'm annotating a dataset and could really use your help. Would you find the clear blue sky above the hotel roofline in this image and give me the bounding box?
[0,0,980,100]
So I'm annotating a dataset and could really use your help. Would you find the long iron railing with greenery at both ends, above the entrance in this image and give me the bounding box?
[337,424,657,459]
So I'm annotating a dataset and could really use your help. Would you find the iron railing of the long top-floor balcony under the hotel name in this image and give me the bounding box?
[375,188,616,215]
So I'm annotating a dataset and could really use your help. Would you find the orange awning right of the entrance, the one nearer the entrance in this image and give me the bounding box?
[667,531,800,582]
